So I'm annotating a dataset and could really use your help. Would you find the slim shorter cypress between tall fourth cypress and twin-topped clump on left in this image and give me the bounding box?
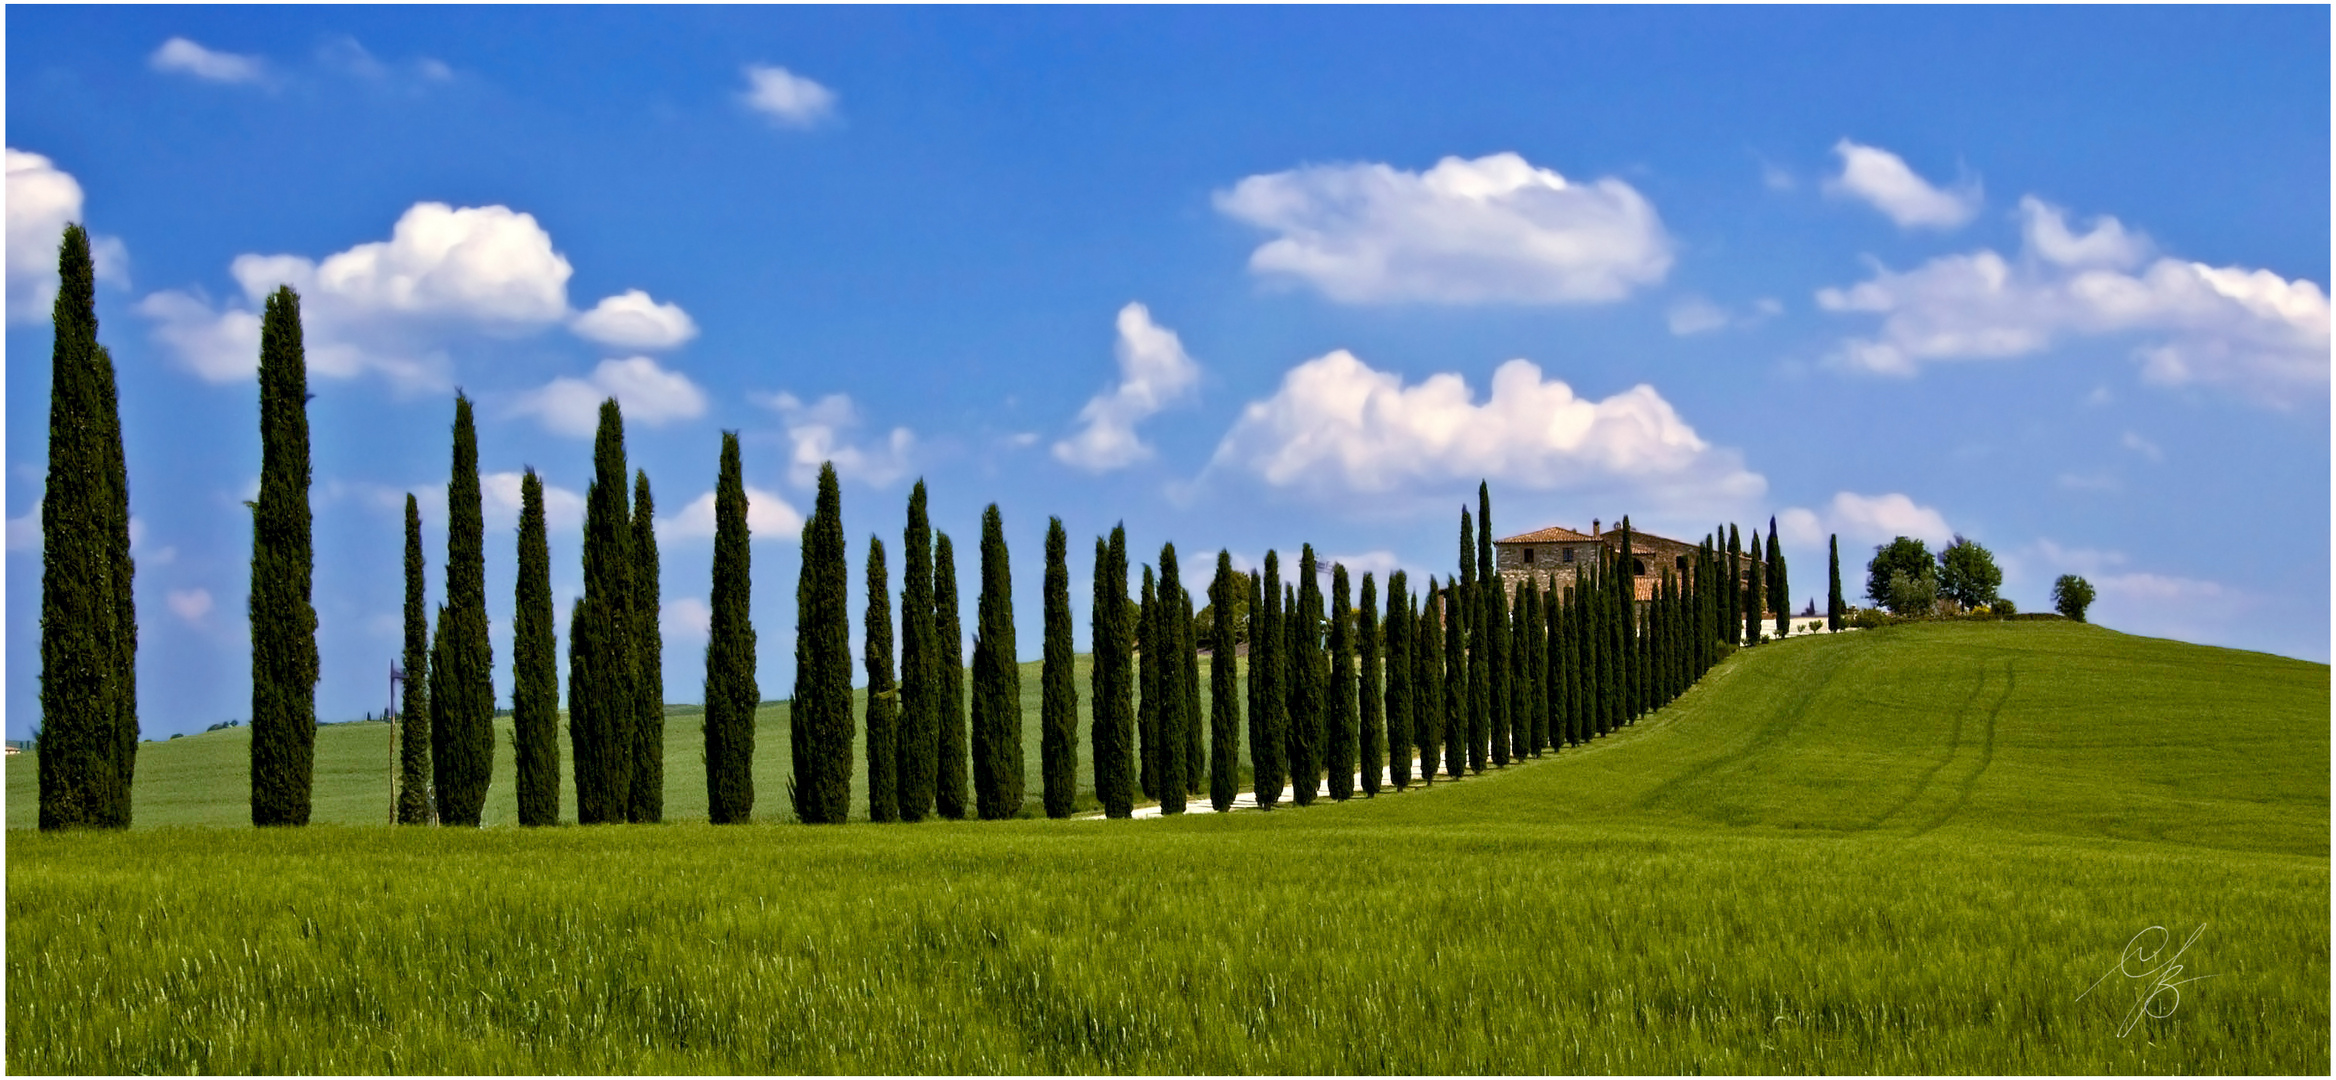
[512,468,561,825]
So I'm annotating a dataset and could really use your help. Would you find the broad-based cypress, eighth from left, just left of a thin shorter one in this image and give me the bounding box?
[787,463,853,825]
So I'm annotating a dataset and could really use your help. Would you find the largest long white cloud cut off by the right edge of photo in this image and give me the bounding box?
[1817,196,2329,404]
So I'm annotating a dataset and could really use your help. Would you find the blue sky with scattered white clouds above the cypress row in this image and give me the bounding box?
[5,7,2329,736]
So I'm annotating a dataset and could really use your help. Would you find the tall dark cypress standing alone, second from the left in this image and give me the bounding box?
[248,288,318,825]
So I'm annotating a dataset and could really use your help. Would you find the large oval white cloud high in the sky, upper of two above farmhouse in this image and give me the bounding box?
[1215,154,1670,304]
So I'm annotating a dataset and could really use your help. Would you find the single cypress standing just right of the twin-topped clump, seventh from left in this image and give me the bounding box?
[705,432,756,825]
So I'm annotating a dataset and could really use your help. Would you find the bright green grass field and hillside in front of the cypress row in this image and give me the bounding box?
[7,622,2329,1073]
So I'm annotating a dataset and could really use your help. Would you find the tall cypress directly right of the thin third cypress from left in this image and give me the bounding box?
[436,393,495,828]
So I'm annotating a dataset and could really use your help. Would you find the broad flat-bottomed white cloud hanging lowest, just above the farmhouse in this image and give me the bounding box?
[1210,348,1766,500]
